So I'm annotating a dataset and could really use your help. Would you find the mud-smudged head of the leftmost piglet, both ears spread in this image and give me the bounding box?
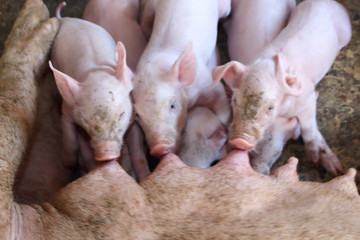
[50,44,133,161]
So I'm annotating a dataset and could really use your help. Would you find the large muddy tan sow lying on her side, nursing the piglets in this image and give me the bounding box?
[0,0,360,240]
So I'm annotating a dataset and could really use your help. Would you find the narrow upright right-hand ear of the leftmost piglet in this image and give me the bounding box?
[115,42,134,91]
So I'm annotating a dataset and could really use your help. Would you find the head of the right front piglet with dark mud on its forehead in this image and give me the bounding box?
[212,55,301,150]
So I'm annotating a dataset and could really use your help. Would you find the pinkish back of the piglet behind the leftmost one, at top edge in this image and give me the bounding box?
[83,0,147,71]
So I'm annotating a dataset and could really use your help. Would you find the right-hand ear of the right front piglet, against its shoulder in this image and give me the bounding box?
[273,54,303,96]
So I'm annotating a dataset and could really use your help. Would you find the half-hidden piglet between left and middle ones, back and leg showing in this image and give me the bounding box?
[83,0,150,181]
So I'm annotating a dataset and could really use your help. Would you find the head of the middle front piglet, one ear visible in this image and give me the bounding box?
[133,45,196,157]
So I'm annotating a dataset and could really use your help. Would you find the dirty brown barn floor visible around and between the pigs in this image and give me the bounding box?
[0,0,360,190]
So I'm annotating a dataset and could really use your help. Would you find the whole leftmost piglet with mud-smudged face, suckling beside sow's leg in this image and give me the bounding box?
[50,18,133,167]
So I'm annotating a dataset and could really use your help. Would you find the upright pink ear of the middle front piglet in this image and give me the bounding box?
[168,43,196,86]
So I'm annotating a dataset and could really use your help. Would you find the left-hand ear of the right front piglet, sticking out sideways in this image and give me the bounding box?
[211,61,246,88]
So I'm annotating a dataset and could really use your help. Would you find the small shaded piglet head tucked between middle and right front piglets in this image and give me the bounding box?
[178,106,227,168]
